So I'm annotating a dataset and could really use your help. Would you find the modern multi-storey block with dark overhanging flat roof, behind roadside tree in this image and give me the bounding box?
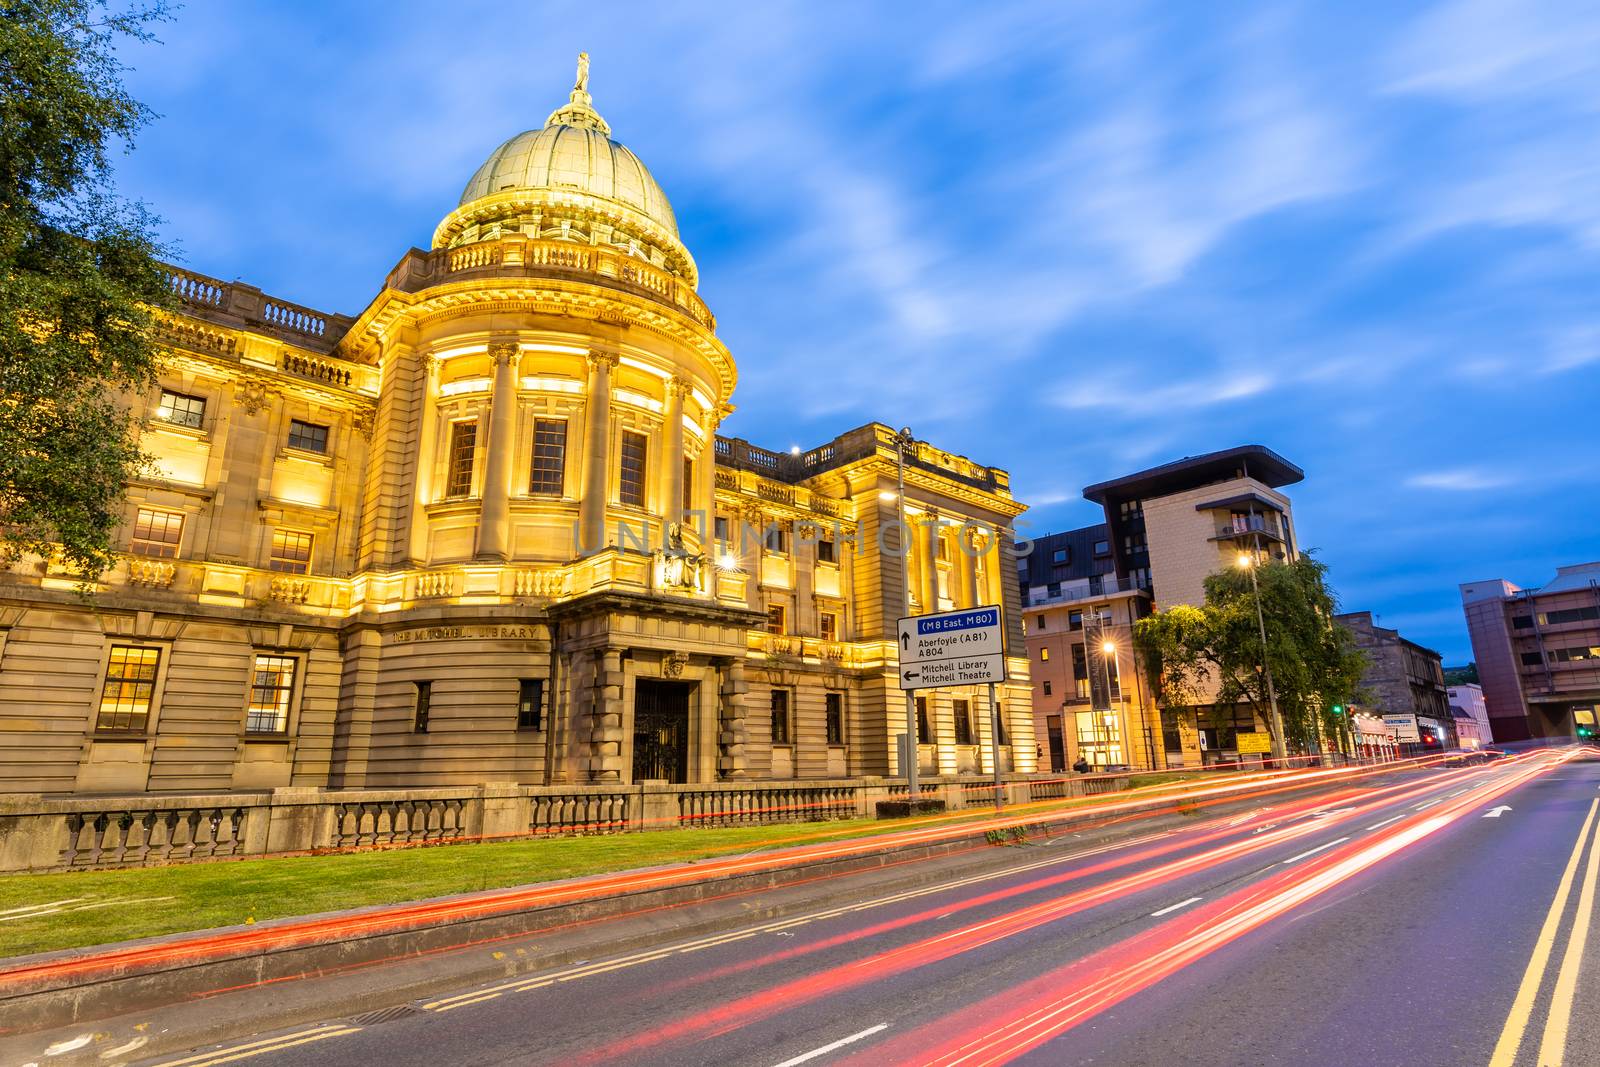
[1018,445,1304,768]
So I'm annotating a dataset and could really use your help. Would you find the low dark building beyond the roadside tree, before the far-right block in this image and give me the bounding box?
[1334,611,1458,752]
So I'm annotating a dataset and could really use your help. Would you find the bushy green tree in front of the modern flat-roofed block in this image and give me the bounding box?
[1133,553,1366,752]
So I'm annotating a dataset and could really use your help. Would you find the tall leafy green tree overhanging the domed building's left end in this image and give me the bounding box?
[0,0,170,579]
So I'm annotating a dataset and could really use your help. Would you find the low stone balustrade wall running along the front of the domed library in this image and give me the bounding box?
[0,774,1128,873]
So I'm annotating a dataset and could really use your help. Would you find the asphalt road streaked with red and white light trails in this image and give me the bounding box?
[137,753,1600,1067]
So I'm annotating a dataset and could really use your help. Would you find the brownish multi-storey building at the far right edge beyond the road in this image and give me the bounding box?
[1461,561,1600,742]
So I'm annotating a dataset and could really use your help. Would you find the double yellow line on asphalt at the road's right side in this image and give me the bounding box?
[1490,800,1600,1067]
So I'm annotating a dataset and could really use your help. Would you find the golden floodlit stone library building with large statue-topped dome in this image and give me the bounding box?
[0,58,1035,793]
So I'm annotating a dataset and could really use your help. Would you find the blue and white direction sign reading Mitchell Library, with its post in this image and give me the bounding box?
[896,605,1005,808]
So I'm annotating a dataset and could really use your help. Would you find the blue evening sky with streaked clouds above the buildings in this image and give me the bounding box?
[106,0,1600,662]
